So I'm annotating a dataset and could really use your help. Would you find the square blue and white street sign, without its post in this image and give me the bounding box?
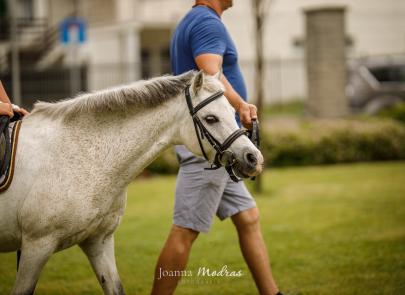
[59,17,86,44]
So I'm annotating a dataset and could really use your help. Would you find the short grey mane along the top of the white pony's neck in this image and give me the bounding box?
[32,71,207,119]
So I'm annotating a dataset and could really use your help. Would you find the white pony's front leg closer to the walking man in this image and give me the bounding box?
[80,234,125,295]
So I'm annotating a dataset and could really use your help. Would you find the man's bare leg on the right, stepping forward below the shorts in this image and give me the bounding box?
[232,207,278,295]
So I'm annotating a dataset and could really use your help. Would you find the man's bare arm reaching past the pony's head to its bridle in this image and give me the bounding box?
[195,53,257,128]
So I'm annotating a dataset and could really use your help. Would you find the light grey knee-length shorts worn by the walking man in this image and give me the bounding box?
[173,146,256,232]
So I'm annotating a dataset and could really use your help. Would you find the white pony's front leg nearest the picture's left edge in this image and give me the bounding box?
[11,238,56,295]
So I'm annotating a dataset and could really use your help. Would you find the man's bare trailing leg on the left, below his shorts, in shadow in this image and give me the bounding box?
[152,225,198,295]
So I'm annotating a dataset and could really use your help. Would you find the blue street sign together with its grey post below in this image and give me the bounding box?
[60,17,86,96]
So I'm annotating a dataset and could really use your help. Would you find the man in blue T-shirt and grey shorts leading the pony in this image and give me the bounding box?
[152,0,281,295]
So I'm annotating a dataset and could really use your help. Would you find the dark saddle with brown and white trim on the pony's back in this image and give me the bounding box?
[0,113,21,193]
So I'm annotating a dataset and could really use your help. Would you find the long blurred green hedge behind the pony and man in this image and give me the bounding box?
[147,119,405,174]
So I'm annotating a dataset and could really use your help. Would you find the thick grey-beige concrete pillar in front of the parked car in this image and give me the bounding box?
[304,6,348,118]
